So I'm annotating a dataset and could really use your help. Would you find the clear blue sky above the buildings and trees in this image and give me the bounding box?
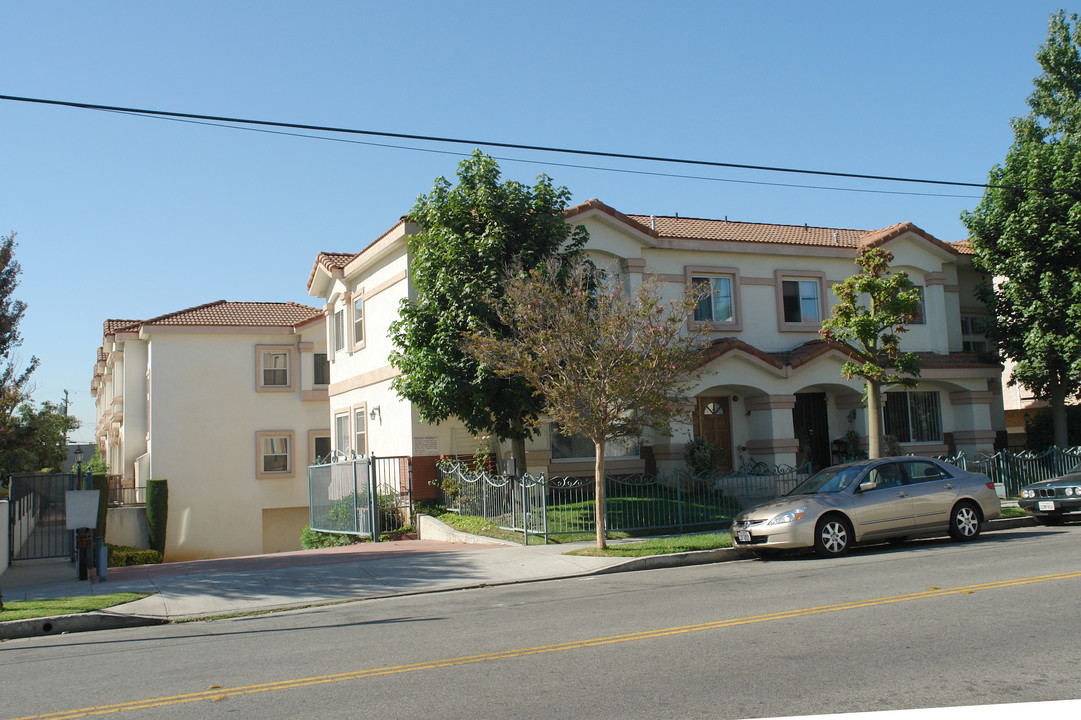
[0,0,1058,441]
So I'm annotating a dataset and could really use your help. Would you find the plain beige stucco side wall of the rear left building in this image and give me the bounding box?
[149,323,328,561]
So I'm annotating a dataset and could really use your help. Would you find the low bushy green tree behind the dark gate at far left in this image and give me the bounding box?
[0,402,79,475]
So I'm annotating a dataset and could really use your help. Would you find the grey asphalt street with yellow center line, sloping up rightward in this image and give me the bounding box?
[0,526,1081,720]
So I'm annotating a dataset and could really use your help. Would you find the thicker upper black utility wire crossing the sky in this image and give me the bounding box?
[0,95,1046,194]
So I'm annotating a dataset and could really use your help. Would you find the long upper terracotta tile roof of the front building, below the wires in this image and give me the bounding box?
[564,198,957,252]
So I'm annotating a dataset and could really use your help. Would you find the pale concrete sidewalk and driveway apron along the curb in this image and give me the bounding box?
[0,510,1033,640]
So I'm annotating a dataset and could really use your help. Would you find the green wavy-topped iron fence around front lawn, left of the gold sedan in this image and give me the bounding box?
[437,462,810,543]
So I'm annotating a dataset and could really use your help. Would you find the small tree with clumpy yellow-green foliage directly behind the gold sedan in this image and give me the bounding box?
[820,248,920,459]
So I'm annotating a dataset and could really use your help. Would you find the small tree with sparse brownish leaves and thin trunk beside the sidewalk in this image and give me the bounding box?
[465,264,705,549]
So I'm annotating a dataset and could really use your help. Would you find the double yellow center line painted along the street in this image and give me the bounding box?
[13,571,1081,720]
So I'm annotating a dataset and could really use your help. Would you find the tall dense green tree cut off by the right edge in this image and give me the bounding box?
[961,11,1081,446]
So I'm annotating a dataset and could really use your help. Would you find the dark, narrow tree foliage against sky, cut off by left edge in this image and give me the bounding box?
[0,231,39,428]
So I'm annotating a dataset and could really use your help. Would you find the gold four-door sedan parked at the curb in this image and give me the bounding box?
[732,457,1002,557]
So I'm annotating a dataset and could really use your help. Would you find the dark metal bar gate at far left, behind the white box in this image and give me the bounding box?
[8,472,76,561]
